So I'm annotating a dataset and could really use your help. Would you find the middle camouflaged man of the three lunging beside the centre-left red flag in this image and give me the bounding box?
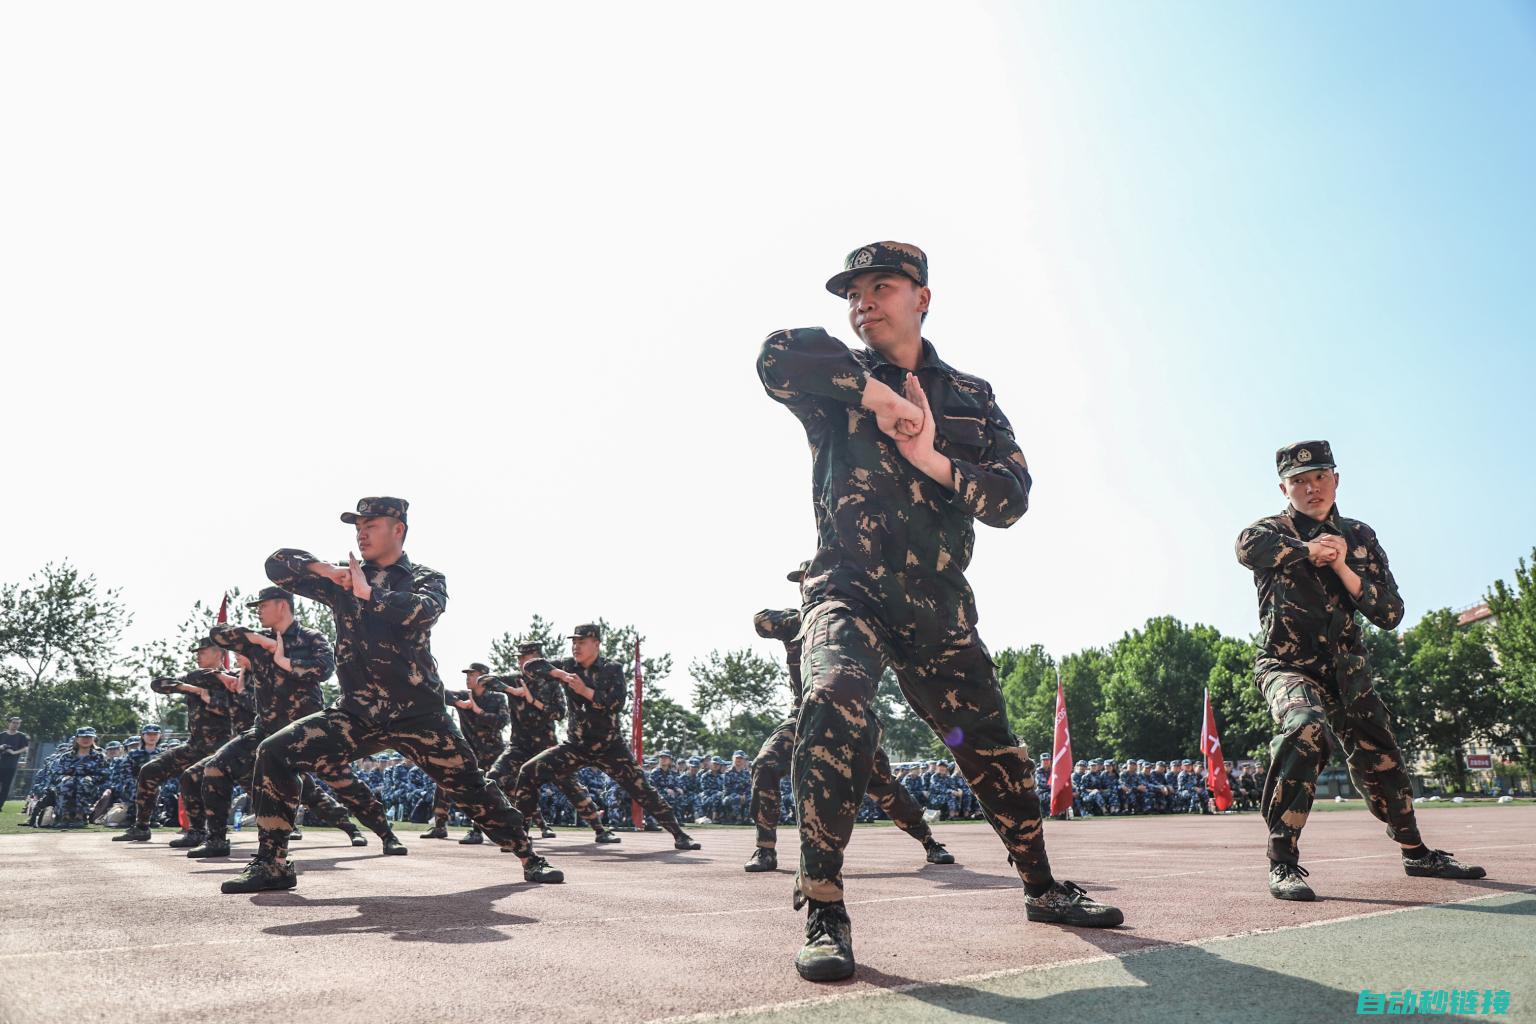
[484,640,605,843]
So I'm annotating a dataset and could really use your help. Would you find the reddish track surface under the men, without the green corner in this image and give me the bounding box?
[0,806,1536,1024]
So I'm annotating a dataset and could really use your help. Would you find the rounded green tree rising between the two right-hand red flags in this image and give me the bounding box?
[1098,616,1221,758]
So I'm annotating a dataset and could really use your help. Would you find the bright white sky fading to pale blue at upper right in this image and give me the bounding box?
[0,2,1536,709]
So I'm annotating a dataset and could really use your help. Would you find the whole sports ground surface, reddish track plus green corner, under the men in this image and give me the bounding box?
[0,806,1536,1024]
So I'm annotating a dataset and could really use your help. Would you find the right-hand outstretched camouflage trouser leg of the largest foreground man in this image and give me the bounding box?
[895,633,1054,886]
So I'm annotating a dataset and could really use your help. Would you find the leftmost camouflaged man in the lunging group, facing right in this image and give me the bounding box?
[112,637,230,846]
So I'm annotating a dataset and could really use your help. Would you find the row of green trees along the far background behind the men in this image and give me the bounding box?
[0,550,1536,789]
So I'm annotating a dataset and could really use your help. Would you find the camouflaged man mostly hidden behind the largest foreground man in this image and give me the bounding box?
[743,577,955,872]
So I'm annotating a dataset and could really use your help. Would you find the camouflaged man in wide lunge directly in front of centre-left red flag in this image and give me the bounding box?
[518,623,699,851]
